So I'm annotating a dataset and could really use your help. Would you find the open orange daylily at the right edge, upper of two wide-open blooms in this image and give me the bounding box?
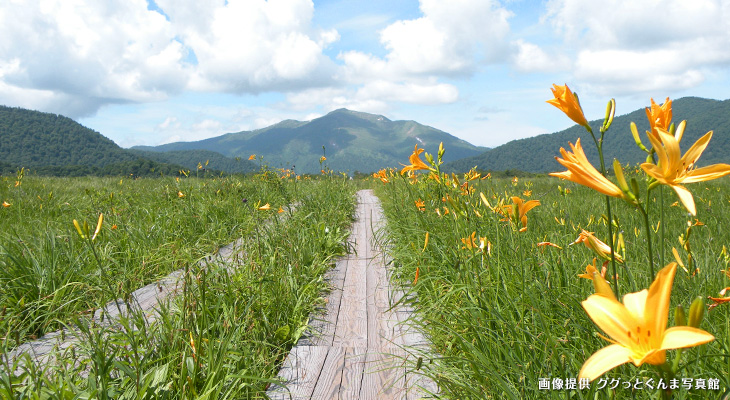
[641,125,730,215]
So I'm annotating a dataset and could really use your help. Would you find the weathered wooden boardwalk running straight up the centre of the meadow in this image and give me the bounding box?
[267,190,437,400]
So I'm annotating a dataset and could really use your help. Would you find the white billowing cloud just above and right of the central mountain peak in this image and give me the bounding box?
[322,0,512,112]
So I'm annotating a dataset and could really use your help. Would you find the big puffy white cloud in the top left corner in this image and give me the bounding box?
[0,0,187,116]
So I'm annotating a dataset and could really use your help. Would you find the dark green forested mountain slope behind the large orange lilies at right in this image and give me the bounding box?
[444,97,730,172]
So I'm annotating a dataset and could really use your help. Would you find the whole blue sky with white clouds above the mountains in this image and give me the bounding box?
[0,0,730,150]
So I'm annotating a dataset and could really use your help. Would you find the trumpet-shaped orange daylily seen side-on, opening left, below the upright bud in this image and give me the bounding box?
[550,138,624,198]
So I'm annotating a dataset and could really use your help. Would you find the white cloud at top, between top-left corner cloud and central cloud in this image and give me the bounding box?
[164,0,339,93]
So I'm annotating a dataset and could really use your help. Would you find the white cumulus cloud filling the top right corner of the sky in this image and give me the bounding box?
[544,0,730,94]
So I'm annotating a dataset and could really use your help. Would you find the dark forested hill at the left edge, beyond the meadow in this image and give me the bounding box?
[0,106,257,176]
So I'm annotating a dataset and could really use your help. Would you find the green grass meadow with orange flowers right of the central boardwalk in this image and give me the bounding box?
[376,170,730,399]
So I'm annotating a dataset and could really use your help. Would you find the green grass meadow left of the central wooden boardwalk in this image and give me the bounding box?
[0,172,354,399]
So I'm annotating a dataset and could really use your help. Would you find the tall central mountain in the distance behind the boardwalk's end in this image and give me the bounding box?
[134,109,484,173]
